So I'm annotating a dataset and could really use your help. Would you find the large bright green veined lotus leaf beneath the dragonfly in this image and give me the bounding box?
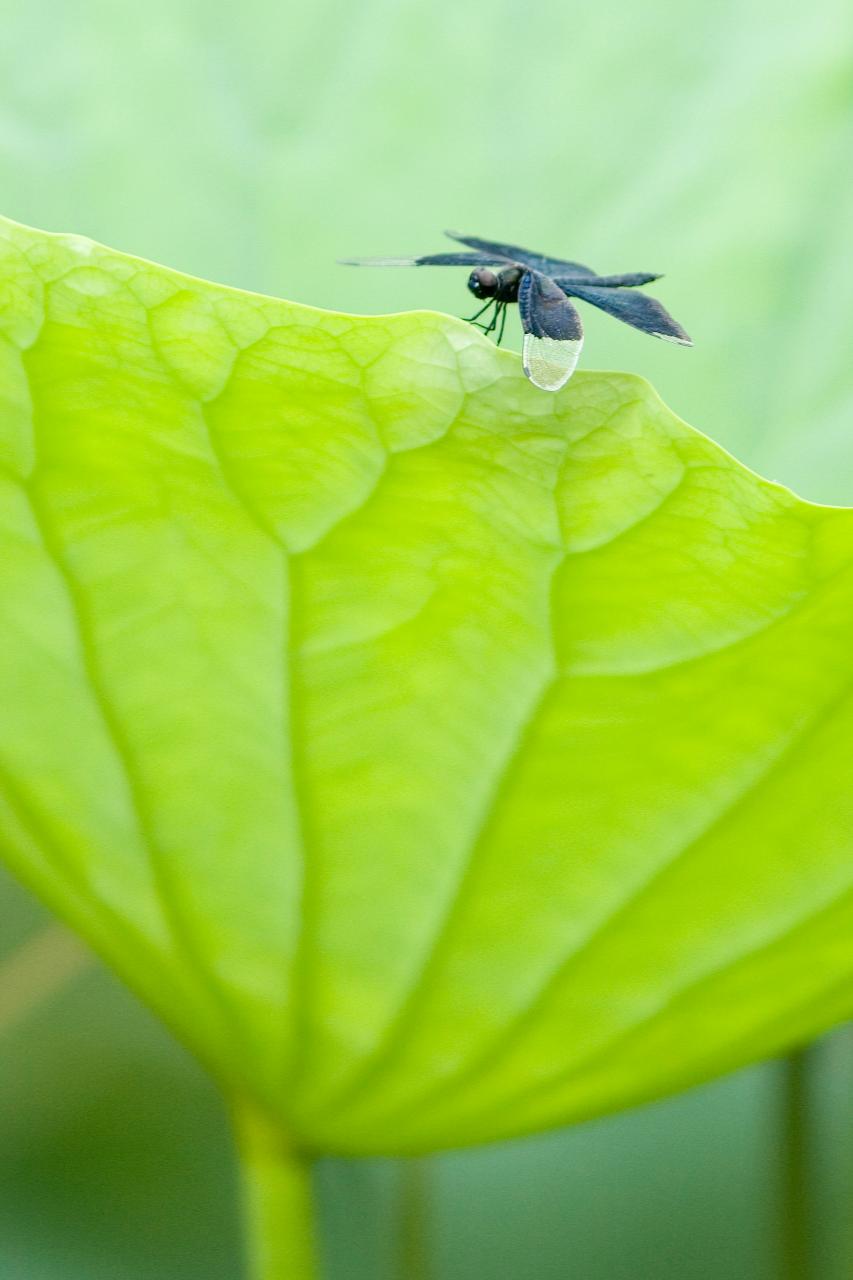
[0,212,853,1153]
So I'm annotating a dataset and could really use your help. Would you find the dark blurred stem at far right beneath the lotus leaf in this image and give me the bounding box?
[780,1047,815,1280]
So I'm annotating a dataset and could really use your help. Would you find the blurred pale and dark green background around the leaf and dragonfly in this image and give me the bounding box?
[0,0,853,1280]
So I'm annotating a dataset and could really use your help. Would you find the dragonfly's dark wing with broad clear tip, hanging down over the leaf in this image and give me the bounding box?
[519,271,584,392]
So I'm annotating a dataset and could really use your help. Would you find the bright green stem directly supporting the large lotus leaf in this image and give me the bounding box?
[233,1101,319,1280]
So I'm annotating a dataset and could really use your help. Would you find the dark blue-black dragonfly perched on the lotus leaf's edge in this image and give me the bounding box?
[342,232,693,392]
